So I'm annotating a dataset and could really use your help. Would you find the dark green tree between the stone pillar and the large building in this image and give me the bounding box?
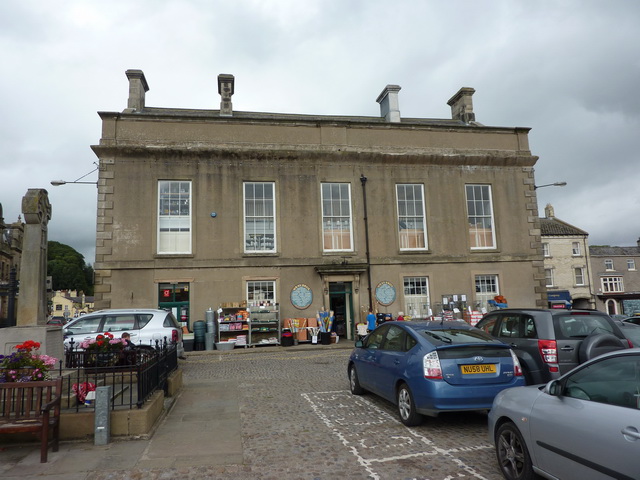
[47,242,93,295]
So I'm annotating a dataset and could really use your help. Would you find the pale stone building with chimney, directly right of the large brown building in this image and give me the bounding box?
[540,205,595,308]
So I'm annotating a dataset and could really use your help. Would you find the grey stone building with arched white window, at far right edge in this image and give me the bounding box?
[589,238,640,315]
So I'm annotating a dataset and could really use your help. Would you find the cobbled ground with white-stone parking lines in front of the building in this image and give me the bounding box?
[93,347,502,480]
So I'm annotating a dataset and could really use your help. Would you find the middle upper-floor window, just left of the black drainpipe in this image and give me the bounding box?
[321,183,353,252]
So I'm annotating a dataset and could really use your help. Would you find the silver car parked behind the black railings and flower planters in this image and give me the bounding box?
[63,308,184,357]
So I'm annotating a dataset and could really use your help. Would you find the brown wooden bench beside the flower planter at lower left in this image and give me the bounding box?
[0,377,62,463]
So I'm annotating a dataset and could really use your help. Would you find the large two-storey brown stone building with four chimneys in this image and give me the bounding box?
[92,70,546,342]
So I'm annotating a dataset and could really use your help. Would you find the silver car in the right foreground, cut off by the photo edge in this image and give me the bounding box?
[489,348,640,480]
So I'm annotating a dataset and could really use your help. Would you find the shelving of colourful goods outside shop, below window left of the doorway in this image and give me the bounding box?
[216,302,281,347]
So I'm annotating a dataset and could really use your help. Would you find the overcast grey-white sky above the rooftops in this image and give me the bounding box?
[0,0,640,263]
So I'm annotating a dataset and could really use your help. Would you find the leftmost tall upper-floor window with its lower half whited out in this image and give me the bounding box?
[157,180,191,254]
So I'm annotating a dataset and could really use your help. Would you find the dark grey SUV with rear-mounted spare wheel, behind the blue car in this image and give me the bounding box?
[476,308,633,385]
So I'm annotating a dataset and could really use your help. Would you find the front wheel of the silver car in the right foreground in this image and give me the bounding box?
[496,422,538,480]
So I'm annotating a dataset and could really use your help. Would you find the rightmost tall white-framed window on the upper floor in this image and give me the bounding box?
[465,185,496,250]
